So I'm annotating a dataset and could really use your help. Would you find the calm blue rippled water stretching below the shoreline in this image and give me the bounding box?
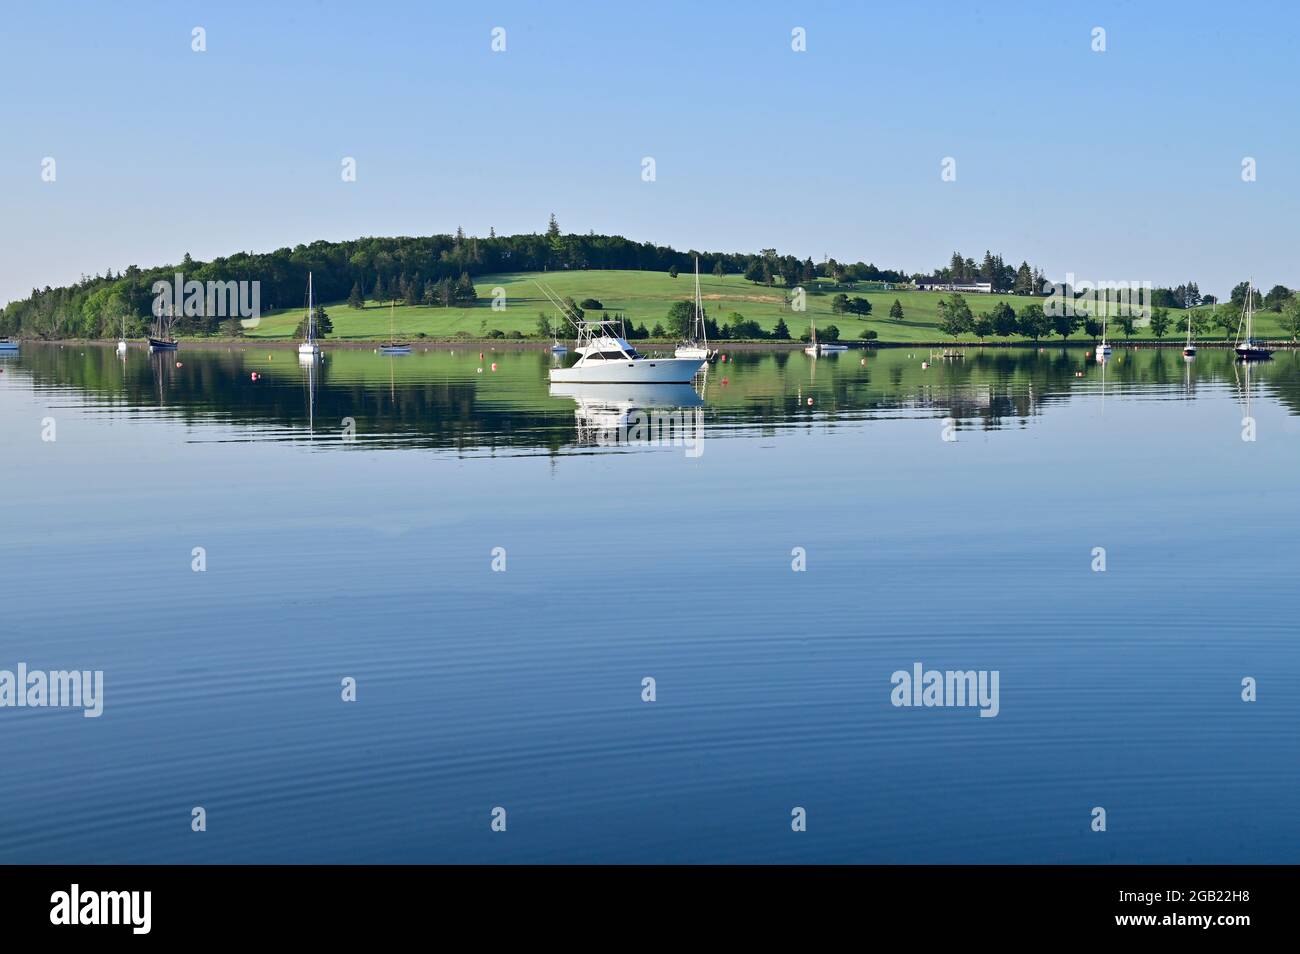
[0,344,1300,863]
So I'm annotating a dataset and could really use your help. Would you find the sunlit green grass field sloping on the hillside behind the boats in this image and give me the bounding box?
[239,270,1286,342]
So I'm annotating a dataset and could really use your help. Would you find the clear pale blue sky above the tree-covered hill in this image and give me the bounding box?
[0,0,1300,303]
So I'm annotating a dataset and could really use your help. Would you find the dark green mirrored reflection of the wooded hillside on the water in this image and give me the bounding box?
[5,343,1300,455]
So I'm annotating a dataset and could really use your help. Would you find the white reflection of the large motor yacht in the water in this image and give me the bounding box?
[550,382,705,448]
